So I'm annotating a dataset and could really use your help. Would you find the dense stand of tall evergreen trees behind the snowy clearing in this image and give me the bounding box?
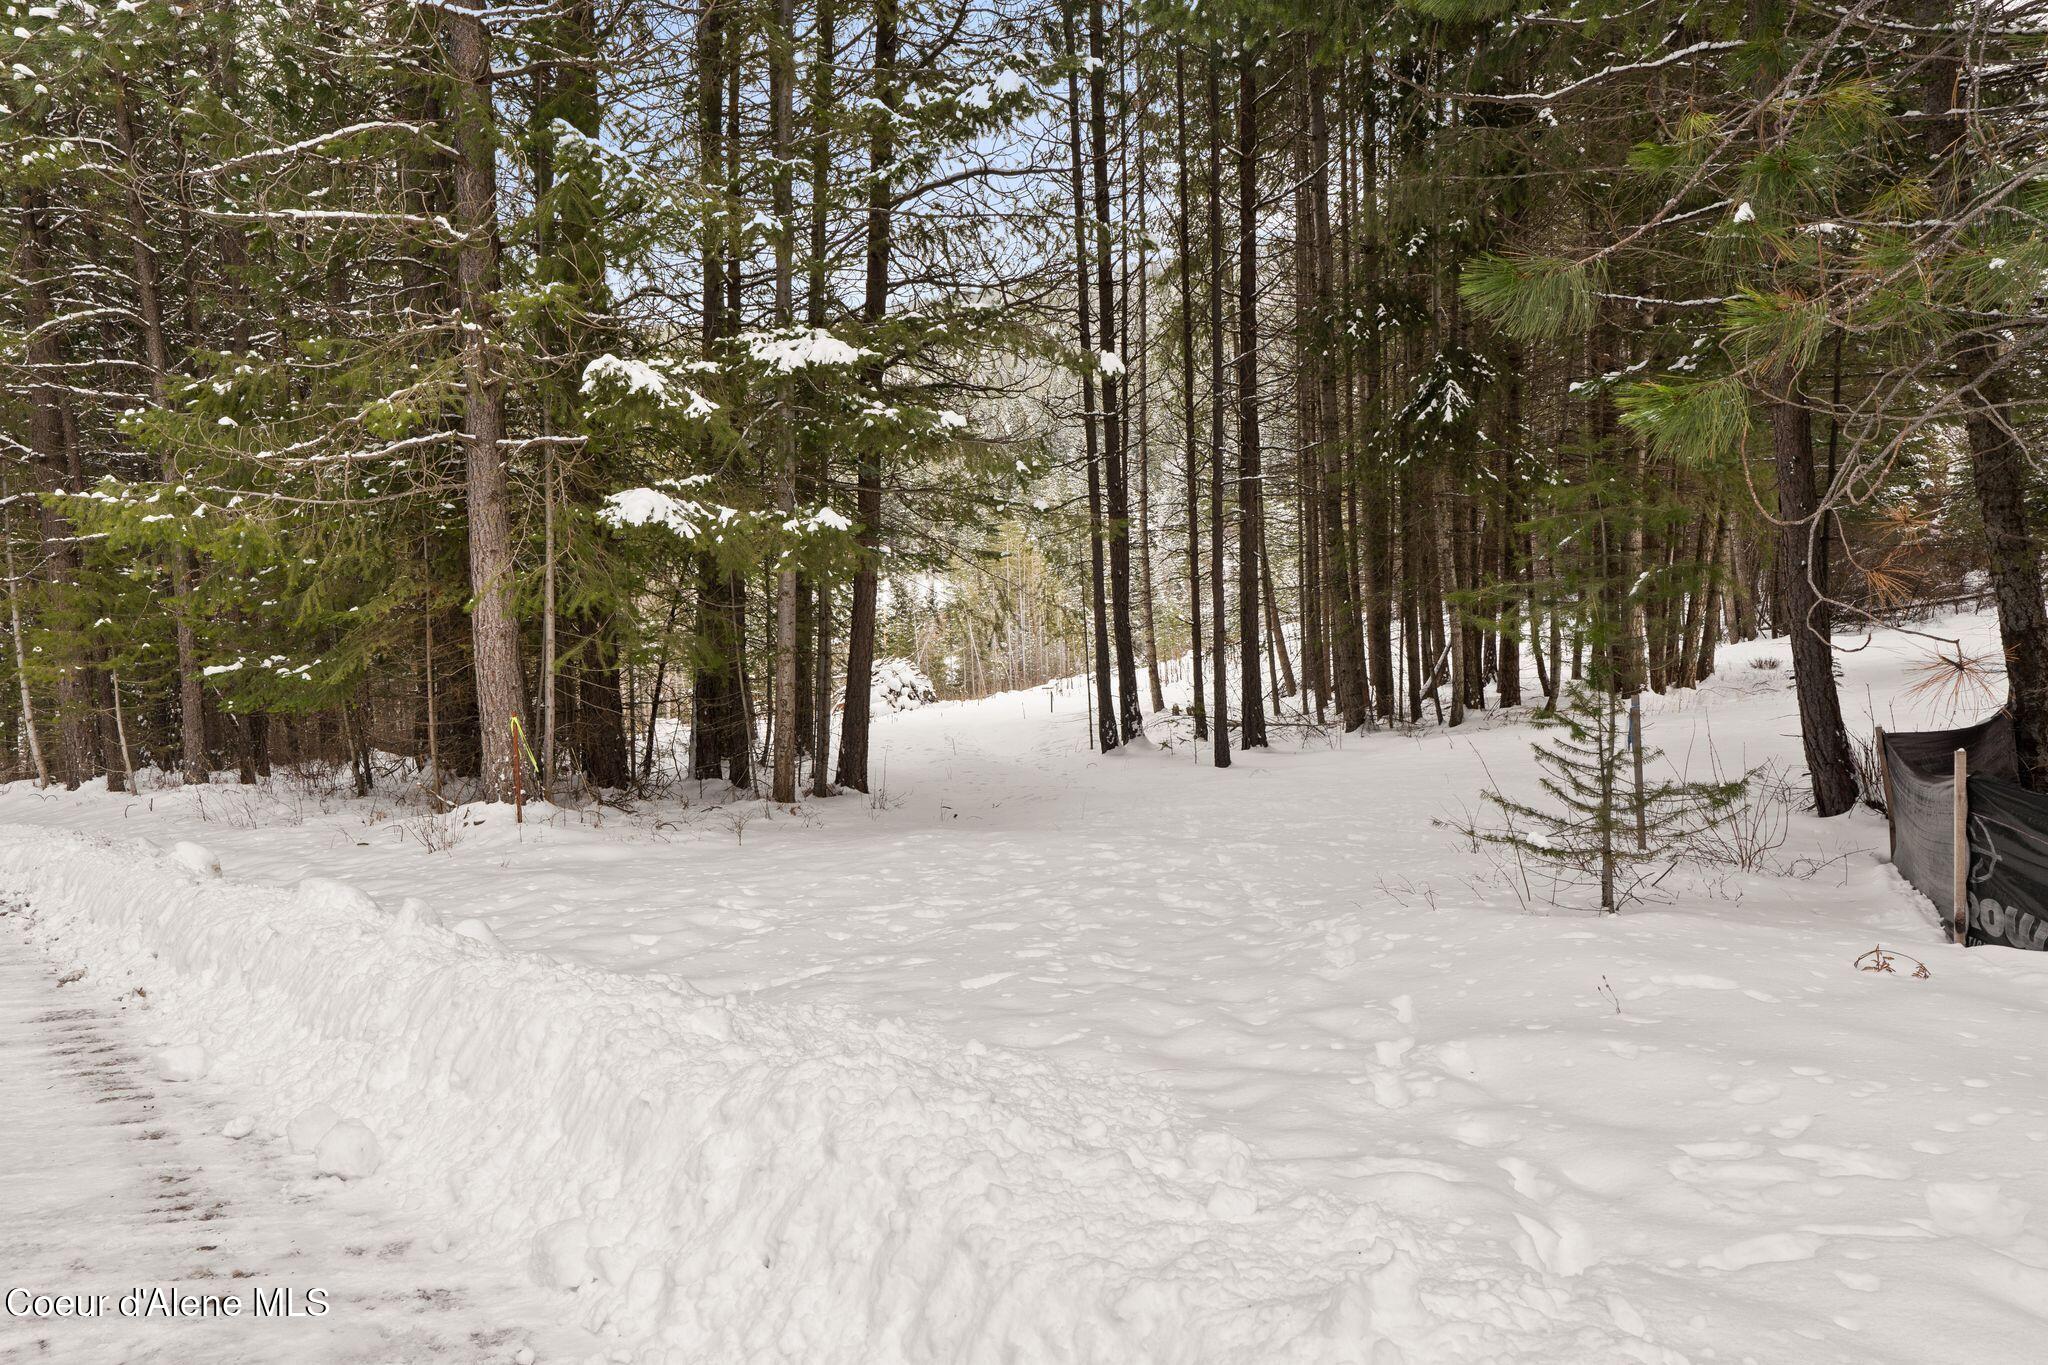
[0,0,2048,814]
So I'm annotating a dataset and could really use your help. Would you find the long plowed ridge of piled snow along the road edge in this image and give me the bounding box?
[0,827,1605,1365]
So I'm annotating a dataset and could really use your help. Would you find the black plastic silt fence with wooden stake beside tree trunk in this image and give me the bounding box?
[1876,714,2048,950]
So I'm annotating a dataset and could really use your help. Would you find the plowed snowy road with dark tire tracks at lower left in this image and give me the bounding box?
[0,905,588,1365]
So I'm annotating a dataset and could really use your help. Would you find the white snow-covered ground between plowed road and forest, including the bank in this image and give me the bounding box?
[0,618,2048,1365]
